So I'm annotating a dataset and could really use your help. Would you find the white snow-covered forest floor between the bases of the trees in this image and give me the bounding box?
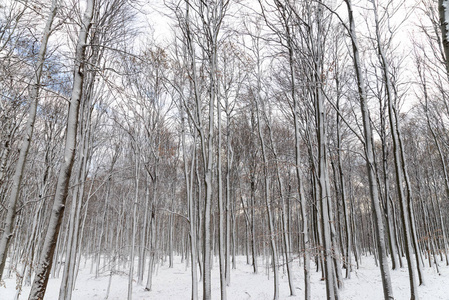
[0,257,449,300]
